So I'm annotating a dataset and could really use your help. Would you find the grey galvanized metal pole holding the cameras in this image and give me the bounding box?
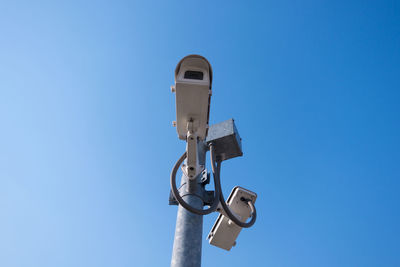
[171,142,206,267]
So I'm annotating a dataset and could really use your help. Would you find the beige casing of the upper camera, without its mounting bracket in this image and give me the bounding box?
[175,55,212,140]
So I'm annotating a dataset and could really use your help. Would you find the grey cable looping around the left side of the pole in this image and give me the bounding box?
[171,152,221,215]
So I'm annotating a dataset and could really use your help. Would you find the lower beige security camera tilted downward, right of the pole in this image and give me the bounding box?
[207,186,257,251]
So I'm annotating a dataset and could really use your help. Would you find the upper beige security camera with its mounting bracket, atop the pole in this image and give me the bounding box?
[172,55,212,179]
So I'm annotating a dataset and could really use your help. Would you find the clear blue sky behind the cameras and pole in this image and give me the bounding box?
[0,0,400,267]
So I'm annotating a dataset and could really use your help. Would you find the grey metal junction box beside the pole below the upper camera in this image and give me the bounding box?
[206,119,243,161]
